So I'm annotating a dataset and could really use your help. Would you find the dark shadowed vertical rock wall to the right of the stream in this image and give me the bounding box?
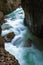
[22,0,43,37]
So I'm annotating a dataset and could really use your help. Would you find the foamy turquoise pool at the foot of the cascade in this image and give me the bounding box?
[5,43,43,65]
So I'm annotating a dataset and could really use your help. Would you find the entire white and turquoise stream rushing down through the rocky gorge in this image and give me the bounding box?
[1,7,43,65]
